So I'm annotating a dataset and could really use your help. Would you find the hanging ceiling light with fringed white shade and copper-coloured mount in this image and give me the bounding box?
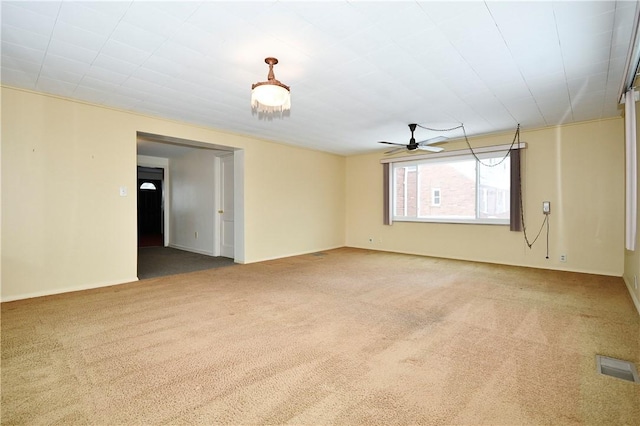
[251,57,291,114]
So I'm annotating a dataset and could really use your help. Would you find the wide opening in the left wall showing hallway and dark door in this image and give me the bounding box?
[137,132,245,282]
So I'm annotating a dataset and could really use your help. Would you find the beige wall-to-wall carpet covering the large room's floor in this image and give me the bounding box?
[1,249,640,425]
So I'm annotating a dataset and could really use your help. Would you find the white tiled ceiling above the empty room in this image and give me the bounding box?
[1,1,638,155]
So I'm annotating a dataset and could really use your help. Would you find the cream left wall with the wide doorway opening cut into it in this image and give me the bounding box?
[1,87,345,301]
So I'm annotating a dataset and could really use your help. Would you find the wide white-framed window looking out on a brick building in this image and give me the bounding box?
[390,151,511,224]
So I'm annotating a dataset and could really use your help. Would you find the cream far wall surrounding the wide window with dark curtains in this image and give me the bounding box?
[346,119,624,276]
